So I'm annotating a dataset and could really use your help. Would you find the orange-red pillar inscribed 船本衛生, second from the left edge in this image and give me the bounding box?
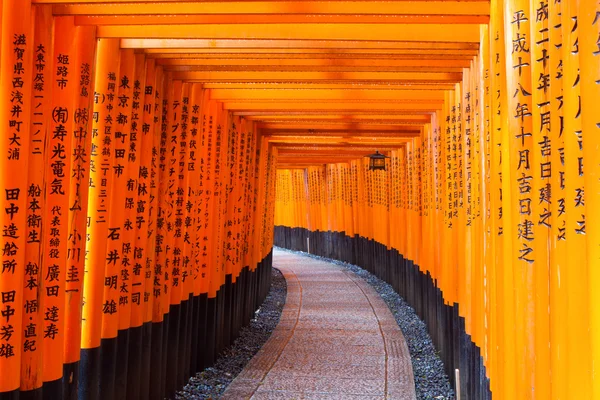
[19,6,54,393]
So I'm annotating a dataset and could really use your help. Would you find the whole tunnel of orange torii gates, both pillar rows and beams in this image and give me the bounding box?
[0,0,600,400]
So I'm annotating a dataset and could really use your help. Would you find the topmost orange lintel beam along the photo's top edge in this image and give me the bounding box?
[51,0,490,16]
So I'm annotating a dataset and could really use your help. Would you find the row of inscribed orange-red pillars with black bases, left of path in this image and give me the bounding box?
[0,0,276,399]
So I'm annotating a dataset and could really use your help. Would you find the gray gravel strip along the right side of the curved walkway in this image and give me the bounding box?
[278,248,454,400]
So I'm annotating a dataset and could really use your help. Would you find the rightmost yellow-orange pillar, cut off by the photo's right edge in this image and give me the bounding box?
[579,2,600,398]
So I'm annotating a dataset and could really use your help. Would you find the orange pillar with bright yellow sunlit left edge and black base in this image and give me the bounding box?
[78,39,119,399]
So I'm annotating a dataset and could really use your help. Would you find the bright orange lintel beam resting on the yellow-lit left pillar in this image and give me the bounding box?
[97,24,479,43]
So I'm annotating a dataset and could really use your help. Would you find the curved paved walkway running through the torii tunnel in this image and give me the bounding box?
[223,250,415,400]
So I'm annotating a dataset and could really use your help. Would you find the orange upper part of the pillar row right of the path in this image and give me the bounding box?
[276,0,600,399]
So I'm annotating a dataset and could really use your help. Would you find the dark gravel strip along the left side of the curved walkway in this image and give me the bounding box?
[176,268,287,400]
